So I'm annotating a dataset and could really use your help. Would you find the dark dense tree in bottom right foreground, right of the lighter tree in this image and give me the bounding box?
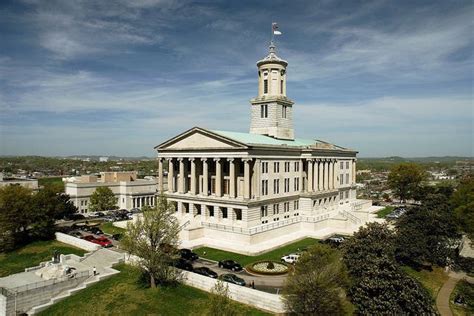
[343,223,435,315]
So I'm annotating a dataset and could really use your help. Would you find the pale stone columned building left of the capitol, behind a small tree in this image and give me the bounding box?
[63,171,157,214]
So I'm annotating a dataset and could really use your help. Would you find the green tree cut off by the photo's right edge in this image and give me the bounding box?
[451,175,474,240]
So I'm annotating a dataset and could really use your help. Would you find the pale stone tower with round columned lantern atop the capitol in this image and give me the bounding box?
[250,42,295,140]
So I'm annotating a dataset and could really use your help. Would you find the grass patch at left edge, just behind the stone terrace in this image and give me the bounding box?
[0,240,85,277]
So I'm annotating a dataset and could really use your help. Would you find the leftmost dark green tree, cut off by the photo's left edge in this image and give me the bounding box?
[0,185,34,252]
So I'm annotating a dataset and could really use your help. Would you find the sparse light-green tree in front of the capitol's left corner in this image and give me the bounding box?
[121,195,180,287]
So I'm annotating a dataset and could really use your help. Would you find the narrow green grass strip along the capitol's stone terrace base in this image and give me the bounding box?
[193,238,318,266]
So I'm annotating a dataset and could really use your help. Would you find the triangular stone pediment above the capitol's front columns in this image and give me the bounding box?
[155,127,247,150]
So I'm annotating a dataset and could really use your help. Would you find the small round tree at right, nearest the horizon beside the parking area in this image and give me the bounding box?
[388,163,426,201]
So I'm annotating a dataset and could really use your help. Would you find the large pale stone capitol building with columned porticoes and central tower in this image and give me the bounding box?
[155,43,379,254]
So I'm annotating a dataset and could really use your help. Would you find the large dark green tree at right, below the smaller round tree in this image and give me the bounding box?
[395,194,458,268]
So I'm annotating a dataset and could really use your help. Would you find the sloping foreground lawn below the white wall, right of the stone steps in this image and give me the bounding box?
[40,264,269,316]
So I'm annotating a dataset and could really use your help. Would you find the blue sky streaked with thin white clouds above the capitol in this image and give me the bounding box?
[0,0,474,157]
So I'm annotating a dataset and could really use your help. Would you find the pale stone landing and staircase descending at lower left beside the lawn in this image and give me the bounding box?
[27,249,125,315]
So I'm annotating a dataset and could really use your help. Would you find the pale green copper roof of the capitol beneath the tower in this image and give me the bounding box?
[211,131,318,147]
